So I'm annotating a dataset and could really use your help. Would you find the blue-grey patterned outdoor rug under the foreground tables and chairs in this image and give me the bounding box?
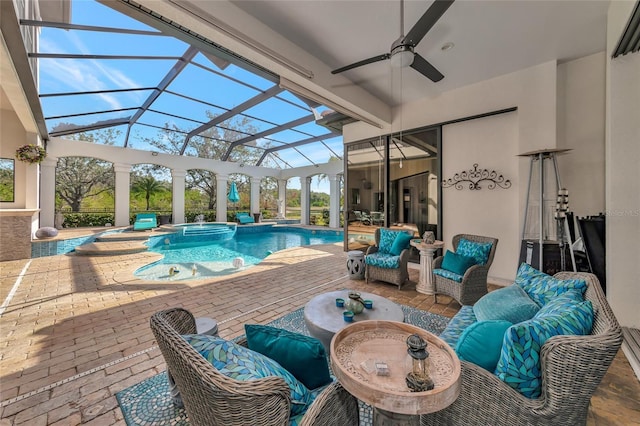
[116,305,449,426]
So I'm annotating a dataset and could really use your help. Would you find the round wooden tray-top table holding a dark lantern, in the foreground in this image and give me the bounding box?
[330,321,460,425]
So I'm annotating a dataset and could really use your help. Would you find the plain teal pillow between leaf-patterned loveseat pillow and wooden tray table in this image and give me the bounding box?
[456,320,512,373]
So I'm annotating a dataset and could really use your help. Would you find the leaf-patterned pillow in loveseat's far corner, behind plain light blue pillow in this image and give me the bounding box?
[516,263,587,306]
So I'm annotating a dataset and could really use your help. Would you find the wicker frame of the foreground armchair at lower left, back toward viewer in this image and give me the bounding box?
[150,308,359,426]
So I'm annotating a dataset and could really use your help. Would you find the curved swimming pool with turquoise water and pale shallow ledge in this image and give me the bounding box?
[134,226,343,281]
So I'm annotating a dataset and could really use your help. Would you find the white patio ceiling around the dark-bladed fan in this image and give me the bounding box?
[229,0,609,105]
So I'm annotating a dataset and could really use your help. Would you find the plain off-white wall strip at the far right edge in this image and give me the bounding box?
[606,1,640,328]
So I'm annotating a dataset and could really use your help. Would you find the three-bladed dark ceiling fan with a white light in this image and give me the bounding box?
[331,0,454,82]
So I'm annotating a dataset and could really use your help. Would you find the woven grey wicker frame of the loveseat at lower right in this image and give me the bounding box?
[420,272,622,426]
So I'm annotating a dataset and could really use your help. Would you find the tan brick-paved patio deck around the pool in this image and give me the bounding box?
[0,228,640,426]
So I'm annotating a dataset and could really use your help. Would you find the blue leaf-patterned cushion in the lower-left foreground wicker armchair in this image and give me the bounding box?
[182,334,314,416]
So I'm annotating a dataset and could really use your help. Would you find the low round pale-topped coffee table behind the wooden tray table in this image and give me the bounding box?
[304,290,404,353]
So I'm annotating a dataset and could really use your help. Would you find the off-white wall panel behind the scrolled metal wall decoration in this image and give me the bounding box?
[442,112,526,284]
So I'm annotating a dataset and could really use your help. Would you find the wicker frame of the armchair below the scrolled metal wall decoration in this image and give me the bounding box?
[433,234,498,305]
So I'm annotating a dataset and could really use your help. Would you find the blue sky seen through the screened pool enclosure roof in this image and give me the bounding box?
[39,0,343,186]
